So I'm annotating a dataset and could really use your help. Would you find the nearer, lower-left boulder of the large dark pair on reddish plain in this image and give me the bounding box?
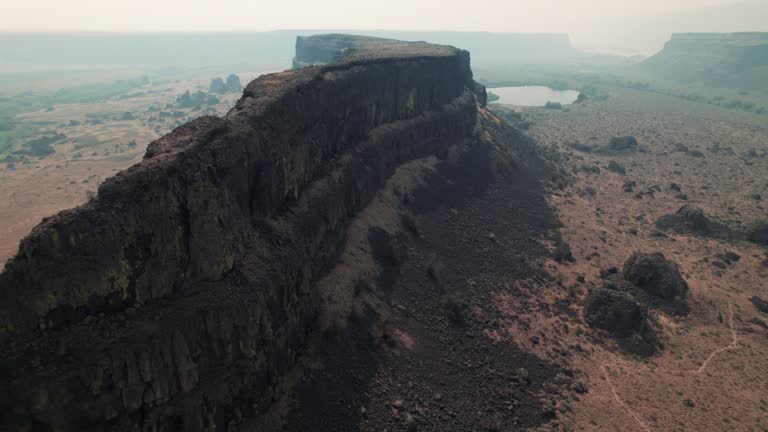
[584,289,647,336]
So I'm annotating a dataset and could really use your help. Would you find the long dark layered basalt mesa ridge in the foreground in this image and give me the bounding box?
[0,35,485,431]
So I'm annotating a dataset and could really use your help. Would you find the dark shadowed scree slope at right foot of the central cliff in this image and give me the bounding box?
[255,111,571,431]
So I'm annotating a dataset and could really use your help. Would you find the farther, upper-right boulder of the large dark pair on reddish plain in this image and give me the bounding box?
[623,252,688,300]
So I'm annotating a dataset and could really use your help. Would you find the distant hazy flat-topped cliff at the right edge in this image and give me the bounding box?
[642,32,768,89]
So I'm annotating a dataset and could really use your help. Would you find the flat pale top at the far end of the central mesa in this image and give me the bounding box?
[297,34,461,63]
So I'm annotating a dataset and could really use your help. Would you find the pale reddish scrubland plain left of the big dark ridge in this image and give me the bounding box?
[0,72,259,268]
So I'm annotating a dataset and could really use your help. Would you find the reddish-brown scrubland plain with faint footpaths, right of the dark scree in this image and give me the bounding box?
[496,88,768,431]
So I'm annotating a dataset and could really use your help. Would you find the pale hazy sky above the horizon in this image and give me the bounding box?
[0,0,768,54]
